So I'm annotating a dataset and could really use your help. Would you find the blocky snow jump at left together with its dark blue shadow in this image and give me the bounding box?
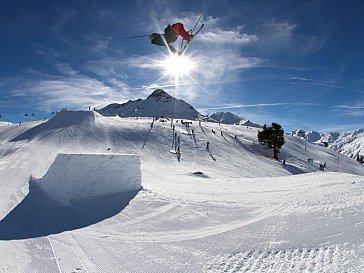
[0,154,141,240]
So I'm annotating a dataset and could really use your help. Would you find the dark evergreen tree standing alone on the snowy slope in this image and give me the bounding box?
[258,122,286,159]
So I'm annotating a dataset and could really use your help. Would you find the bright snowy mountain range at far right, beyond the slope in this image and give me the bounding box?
[306,129,364,157]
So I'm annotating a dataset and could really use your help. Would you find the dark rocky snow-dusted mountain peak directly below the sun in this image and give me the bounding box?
[99,89,201,120]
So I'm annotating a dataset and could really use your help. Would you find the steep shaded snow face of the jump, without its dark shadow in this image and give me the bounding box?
[37,154,141,204]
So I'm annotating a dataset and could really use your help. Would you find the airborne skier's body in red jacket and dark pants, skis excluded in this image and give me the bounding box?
[149,23,193,53]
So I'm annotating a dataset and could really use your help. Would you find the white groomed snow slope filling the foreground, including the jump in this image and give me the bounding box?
[0,111,364,273]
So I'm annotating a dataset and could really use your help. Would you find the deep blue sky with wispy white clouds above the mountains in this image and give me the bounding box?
[0,0,364,131]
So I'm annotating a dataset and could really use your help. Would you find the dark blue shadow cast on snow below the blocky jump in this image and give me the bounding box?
[0,181,138,240]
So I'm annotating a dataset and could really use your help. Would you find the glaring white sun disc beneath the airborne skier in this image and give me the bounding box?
[161,54,196,77]
